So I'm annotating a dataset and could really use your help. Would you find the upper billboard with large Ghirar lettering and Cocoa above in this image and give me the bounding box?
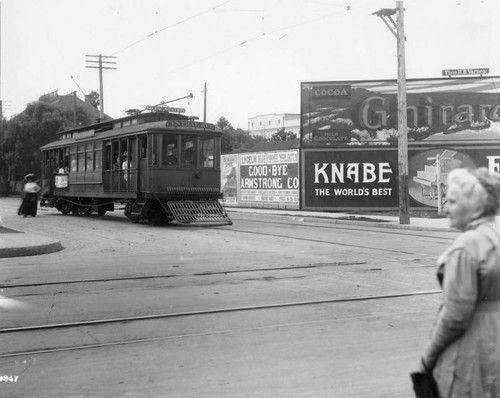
[301,76,500,147]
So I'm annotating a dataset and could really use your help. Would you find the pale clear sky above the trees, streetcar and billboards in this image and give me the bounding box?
[0,0,500,130]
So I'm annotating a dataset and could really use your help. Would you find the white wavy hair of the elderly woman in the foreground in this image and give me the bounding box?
[448,167,500,216]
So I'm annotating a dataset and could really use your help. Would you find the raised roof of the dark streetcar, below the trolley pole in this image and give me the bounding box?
[40,112,222,150]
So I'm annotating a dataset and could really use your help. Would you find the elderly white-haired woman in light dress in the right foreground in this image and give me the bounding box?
[422,168,500,398]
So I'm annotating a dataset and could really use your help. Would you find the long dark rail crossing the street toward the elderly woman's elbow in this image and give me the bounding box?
[0,290,441,334]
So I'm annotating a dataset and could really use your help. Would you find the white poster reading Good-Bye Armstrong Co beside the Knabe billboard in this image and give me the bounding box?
[239,150,300,208]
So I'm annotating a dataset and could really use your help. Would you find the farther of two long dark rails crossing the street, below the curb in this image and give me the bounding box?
[0,261,366,289]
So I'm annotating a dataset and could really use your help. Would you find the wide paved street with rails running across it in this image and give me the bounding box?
[0,198,456,398]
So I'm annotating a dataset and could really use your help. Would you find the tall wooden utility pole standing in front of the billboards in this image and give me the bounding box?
[373,1,410,224]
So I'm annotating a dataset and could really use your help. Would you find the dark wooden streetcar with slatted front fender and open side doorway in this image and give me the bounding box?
[40,107,232,224]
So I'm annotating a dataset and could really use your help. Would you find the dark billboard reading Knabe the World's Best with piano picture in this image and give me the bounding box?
[301,143,500,211]
